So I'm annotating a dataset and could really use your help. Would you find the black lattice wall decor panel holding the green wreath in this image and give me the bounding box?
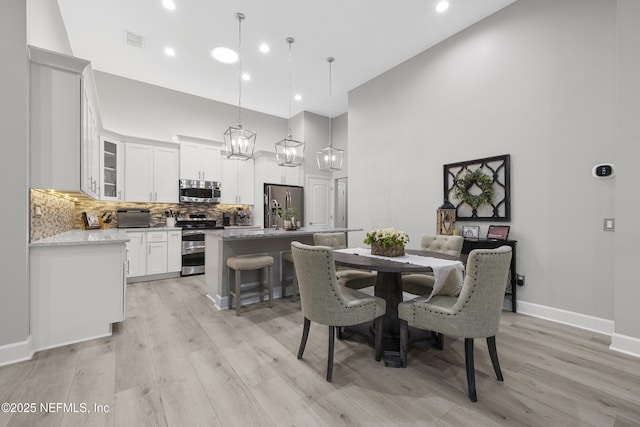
[443,154,511,222]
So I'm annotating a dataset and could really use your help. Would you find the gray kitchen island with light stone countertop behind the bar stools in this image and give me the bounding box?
[205,227,362,309]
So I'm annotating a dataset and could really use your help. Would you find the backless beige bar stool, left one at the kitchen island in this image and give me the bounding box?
[227,254,273,316]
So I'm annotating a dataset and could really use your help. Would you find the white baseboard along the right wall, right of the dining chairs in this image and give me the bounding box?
[518,301,640,357]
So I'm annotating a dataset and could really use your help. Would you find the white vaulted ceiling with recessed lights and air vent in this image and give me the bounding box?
[58,0,515,118]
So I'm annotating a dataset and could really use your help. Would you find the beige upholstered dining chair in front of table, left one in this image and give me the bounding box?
[291,242,386,382]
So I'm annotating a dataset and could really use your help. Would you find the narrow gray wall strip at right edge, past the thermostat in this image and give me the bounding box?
[614,0,640,342]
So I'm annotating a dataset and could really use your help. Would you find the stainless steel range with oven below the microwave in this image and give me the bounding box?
[176,214,224,276]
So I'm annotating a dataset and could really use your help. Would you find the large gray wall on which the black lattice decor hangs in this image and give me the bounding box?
[348,0,620,321]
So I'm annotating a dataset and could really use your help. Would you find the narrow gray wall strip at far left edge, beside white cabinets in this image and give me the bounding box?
[0,0,29,348]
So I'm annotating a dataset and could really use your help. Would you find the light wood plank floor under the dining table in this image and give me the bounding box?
[0,276,640,427]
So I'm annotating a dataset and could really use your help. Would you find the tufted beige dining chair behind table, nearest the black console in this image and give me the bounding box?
[402,234,464,295]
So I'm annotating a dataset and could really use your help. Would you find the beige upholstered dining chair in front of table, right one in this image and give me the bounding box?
[398,246,511,402]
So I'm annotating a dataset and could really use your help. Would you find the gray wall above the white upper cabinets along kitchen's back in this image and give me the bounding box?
[93,71,288,151]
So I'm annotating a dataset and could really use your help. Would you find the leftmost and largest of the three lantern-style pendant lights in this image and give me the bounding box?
[224,12,257,160]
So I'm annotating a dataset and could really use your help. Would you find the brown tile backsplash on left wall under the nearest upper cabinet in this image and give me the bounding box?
[29,190,77,242]
